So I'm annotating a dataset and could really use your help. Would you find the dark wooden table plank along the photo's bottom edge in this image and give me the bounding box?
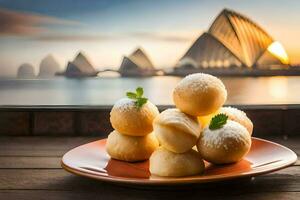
[0,191,300,200]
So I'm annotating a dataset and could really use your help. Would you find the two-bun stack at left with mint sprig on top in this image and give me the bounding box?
[106,88,159,162]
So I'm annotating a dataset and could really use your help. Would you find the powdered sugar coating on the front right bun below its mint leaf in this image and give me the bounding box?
[201,120,250,149]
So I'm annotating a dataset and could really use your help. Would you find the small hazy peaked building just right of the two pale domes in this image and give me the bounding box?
[58,52,98,77]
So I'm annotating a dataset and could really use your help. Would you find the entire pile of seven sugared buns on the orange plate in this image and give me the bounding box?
[106,73,253,177]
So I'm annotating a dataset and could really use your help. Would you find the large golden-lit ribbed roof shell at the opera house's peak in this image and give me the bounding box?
[208,9,273,67]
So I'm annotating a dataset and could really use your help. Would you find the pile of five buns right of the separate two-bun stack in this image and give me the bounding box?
[150,73,253,176]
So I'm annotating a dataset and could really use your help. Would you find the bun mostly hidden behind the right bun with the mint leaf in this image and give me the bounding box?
[219,107,253,135]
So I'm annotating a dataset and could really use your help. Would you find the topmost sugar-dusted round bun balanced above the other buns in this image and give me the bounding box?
[173,73,227,116]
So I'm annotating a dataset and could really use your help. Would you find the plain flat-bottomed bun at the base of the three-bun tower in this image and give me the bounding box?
[149,147,205,177]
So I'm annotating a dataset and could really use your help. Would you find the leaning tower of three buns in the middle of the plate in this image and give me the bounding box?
[150,74,227,176]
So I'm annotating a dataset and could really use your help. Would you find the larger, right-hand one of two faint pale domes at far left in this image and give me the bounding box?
[38,55,60,78]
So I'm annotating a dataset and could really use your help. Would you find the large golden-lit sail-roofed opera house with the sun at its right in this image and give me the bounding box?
[176,9,289,71]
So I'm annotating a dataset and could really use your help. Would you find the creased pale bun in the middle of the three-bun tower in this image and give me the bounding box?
[153,108,200,153]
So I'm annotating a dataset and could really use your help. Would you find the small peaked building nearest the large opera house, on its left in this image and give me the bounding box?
[118,48,156,76]
